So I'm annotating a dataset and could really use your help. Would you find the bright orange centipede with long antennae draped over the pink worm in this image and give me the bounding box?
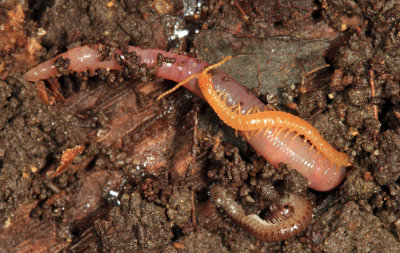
[157,56,352,168]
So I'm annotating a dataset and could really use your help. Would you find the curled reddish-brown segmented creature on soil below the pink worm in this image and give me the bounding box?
[210,186,313,242]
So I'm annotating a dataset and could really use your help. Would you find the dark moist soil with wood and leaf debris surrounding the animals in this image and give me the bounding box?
[0,0,400,252]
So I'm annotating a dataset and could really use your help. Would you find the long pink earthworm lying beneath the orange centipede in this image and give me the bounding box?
[24,45,346,191]
